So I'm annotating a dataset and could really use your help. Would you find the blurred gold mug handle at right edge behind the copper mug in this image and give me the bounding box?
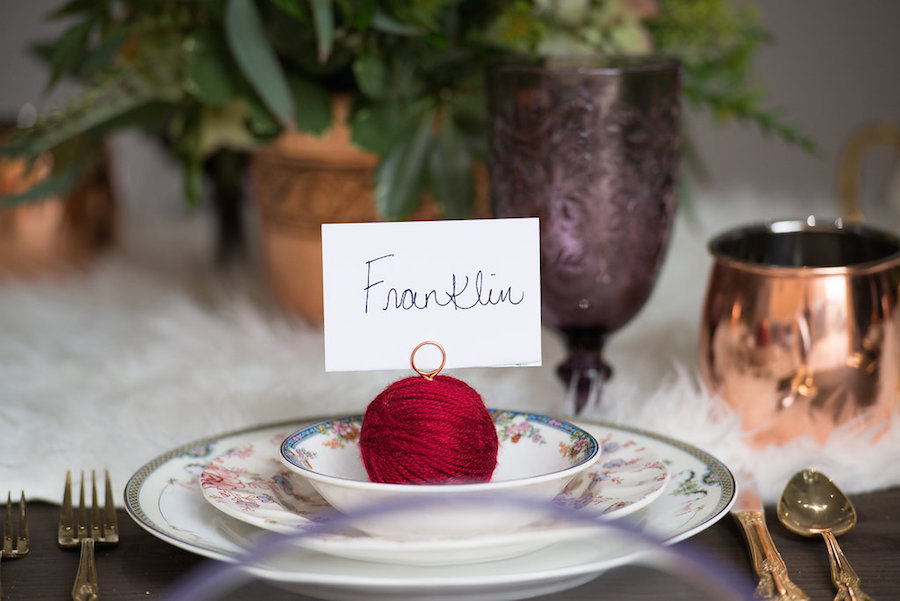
[838,121,900,221]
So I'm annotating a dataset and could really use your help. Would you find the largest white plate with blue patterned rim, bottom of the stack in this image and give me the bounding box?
[125,418,735,601]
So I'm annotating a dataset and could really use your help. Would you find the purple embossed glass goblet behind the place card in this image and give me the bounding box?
[488,57,681,414]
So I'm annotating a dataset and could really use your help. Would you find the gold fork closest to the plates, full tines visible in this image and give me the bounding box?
[57,470,119,601]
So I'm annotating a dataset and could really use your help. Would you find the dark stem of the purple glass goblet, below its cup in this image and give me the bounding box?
[556,332,613,415]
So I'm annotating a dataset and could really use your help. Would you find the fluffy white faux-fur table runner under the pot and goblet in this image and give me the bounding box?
[0,186,900,502]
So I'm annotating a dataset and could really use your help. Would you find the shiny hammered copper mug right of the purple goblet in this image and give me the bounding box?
[700,218,900,445]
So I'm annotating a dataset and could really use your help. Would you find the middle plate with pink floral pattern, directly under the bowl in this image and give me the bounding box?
[200,422,669,565]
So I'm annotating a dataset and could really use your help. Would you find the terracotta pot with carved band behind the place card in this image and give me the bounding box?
[250,97,487,324]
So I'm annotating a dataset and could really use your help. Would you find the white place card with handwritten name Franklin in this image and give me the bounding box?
[322,218,541,371]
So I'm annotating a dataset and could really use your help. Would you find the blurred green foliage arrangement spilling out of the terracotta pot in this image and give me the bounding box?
[4,0,812,218]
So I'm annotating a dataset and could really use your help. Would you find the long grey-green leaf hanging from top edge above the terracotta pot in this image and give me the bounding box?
[225,0,294,127]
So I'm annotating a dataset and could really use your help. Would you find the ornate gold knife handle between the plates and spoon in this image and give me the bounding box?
[734,511,809,601]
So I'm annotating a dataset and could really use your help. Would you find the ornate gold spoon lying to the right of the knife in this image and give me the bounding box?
[778,469,874,601]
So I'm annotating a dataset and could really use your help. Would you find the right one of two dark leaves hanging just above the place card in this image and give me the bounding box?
[428,114,475,219]
